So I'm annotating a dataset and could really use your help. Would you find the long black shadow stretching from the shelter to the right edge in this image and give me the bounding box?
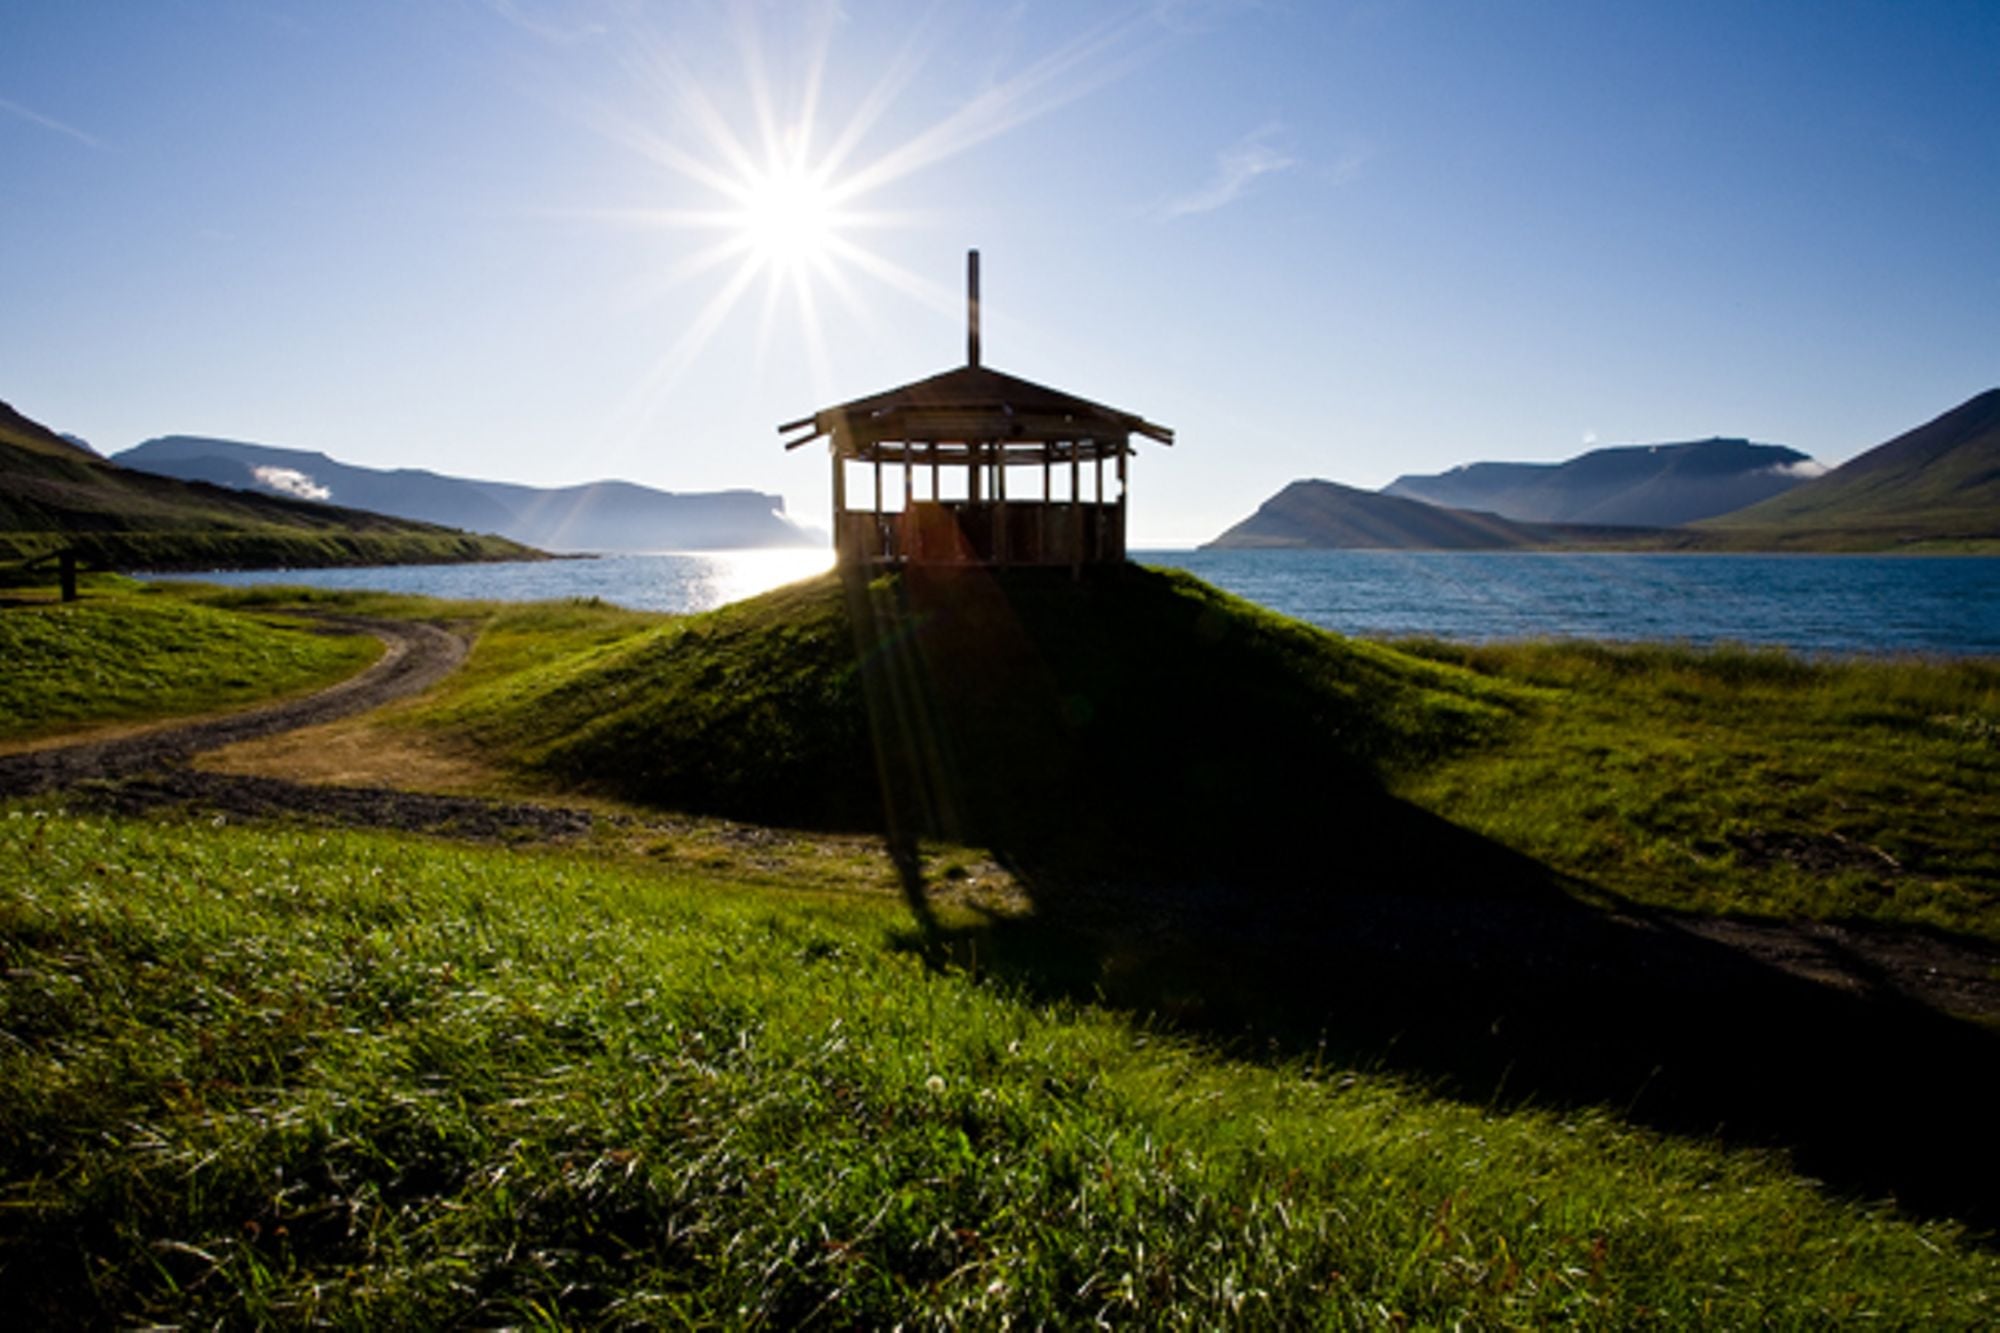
[870,560,2000,1235]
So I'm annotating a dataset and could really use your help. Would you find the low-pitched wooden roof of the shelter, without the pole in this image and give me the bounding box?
[778,366,1174,448]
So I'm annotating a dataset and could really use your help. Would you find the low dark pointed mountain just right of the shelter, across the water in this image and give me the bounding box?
[1206,480,1656,550]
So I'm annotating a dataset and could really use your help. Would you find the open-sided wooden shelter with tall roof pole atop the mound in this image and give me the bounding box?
[778,250,1174,570]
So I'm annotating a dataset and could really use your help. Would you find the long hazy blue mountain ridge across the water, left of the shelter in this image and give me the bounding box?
[114,434,816,550]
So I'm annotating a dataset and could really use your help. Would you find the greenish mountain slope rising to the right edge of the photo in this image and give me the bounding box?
[1698,388,2000,550]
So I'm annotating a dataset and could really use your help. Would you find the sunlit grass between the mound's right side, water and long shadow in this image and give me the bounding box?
[1398,642,2000,939]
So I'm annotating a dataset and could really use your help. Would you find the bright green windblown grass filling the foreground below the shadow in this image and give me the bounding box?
[0,805,2000,1327]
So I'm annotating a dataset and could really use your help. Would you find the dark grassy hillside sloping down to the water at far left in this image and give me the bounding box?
[0,392,538,568]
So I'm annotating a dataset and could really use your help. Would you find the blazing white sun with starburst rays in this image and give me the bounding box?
[584,0,1154,396]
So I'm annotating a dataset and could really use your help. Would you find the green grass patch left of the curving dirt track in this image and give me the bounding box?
[0,578,382,741]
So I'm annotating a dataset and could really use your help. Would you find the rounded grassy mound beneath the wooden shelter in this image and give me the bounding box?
[440,566,1512,845]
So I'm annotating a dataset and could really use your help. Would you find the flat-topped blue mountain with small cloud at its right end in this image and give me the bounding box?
[1382,438,1822,528]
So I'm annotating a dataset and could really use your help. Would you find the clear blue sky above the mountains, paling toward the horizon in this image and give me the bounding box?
[0,0,2000,544]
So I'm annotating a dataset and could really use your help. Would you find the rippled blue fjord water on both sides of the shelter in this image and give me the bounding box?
[152,548,2000,656]
